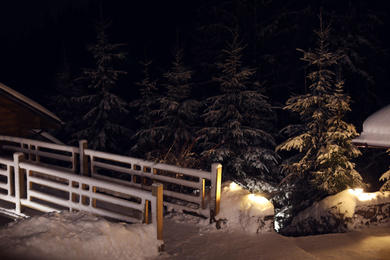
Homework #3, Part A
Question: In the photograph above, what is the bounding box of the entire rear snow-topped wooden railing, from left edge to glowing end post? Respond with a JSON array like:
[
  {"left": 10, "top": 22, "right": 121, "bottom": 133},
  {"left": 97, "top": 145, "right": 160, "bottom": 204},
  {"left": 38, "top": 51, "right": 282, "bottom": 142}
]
[{"left": 0, "top": 136, "right": 222, "bottom": 219}]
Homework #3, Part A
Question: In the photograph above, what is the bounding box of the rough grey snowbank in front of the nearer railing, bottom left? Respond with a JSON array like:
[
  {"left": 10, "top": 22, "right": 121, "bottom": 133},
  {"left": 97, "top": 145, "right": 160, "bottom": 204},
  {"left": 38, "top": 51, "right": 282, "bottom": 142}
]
[{"left": 0, "top": 211, "right": 161, "bottom": 260}]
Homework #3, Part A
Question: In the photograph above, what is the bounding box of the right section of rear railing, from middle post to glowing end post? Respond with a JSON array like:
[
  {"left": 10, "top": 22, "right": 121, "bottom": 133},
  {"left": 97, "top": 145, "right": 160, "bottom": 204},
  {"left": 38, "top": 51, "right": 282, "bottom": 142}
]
[{"left": 84, "top": 146, "right": 222, "bottom": 218}]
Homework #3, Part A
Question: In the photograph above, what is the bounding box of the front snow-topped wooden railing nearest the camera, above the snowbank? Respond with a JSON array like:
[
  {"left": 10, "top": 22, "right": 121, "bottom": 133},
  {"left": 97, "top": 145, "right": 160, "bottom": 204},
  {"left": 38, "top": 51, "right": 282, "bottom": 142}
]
[{"left": 0, "top": 152, "right": 163, "bottom": 240}]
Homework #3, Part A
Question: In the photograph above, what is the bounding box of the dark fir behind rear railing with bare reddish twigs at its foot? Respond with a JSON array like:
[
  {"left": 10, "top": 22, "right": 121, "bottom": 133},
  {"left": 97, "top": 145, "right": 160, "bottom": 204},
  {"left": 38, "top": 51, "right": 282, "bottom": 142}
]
[{"left": 152, "top": 45, "right": 201, "bottom": 167}]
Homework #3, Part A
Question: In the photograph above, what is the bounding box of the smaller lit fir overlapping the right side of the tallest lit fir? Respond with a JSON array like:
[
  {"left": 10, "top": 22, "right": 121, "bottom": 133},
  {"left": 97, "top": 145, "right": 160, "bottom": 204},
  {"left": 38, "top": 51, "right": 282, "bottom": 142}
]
[{"left": 314, "top": 81, "right": 365, "bottom": 194}]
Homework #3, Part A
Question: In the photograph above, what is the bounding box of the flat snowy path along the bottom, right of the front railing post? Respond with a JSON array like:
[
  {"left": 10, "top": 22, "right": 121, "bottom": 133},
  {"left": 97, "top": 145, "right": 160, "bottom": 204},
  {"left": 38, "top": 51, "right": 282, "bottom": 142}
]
[{"left": 155, "top": 218, "right": 390, "bottom": 260}]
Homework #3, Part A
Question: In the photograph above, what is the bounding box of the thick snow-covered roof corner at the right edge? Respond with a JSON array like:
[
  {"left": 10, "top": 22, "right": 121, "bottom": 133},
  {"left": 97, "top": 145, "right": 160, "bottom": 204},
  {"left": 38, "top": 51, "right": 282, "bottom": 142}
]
[{"left": 352, "top": 105, "right": 390, "bottom": 148}]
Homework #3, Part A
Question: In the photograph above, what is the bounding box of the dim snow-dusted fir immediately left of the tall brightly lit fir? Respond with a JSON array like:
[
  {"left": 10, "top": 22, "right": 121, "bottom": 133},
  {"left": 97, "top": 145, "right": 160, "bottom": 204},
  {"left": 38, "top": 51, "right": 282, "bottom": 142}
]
[{"left": 201, "top": 32, "right": 276, "bottom": 183}]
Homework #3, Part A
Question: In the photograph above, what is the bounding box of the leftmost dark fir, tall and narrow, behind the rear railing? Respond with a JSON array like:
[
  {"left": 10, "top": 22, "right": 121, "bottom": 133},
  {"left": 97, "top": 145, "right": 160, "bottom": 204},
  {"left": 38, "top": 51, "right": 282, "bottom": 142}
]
[{"left": 76, "top": 19, "right": 130, "bottom": 152}]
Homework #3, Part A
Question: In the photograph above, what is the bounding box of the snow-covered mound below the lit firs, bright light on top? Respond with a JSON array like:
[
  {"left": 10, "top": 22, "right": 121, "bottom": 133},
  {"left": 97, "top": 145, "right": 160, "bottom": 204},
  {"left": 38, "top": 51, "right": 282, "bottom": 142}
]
[{"left": 284, "top": 189, "right": 390, "bottom": 235}]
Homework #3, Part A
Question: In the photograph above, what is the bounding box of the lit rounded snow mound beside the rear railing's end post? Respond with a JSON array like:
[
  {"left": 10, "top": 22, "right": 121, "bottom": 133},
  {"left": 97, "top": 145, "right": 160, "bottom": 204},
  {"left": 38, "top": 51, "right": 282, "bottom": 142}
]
[{"left": 216, "top": 182, "right": 274, "bottom": 233}]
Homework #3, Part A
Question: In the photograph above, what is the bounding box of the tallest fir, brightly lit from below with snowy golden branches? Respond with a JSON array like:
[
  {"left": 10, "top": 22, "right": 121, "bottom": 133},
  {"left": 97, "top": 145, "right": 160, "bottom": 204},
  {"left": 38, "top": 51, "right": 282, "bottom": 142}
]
[{"left": 277, "top": 15, "right": 363, "bottom": 197}]
